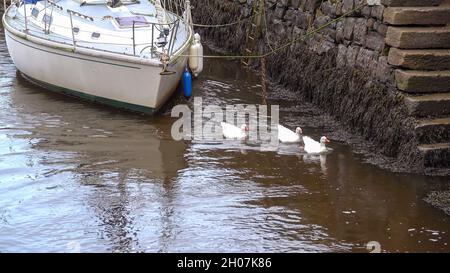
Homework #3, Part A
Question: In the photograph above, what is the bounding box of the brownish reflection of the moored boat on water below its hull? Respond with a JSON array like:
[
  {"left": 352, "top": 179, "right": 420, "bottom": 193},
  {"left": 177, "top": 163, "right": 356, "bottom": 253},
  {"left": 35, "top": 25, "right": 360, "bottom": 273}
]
[{"left": 10, "top": 72, "right": 187, "bottom": 180}]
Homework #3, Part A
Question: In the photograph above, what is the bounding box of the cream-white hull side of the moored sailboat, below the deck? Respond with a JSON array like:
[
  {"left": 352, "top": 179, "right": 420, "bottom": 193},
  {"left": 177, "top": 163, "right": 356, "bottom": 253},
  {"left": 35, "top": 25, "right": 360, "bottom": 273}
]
[{"left": 5, "top": 26, "right": 187, "bottom": 114}]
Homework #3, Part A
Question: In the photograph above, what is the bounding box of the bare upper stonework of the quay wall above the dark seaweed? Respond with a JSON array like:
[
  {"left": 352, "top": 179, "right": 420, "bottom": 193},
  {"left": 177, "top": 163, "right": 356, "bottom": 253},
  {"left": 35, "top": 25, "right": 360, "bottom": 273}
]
[{"left": 194, "top": 0, "right": 394, "bottom": 84}]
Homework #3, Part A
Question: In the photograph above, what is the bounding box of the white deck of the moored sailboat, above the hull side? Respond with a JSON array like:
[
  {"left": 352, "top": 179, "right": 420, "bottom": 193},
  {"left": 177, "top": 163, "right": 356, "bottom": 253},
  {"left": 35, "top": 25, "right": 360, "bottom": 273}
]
[{"left": 5, "top": 0, "right": 190, "bottom": 59}]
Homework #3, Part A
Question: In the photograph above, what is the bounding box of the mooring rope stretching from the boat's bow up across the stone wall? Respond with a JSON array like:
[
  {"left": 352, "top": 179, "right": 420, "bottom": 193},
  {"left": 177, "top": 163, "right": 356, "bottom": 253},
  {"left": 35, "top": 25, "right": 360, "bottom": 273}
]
[{"left": 178, "top": 4, "right": 367, "bottom": 59}]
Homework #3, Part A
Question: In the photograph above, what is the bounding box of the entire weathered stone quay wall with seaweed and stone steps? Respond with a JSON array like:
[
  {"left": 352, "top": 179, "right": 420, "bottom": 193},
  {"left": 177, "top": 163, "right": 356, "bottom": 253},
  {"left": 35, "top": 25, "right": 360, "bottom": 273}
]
[{"left": 192, "top": 0, "right": 450, "bottom": 172}]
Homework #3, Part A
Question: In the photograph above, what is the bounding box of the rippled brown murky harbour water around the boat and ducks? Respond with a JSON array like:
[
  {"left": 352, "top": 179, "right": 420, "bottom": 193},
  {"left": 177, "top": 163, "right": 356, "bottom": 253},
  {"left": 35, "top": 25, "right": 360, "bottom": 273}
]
[{"left": 0, "top": 24, "right": 450, "bottom": 252}]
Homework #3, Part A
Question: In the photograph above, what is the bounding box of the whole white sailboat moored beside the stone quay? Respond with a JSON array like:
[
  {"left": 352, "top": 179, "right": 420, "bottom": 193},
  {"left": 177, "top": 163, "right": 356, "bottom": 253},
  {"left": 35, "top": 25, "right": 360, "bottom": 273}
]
[{"left": 3, "top": 0, "right": 199, "bottom": 114}]
